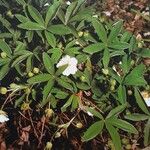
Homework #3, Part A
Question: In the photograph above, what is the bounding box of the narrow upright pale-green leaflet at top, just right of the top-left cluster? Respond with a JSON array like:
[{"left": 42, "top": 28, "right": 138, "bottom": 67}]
[{"left": 65, "top": 1, "right": 78, "bottom": 25}]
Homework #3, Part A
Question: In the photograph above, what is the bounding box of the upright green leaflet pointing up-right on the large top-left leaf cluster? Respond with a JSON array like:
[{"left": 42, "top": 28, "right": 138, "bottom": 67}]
[{"left": 45, "top": 1, "right": 60, "bottom": 27}]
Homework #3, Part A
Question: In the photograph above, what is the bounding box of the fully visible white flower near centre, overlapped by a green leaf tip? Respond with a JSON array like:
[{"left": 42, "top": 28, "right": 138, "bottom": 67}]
[{"left": 56, "top": 55, "right": 78, "bottom": 76}]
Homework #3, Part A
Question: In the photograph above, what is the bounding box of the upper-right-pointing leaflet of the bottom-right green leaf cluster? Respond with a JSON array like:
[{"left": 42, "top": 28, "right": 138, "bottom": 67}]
[{"left": 106, "top": 104, "right": 127, "bottom": 118}]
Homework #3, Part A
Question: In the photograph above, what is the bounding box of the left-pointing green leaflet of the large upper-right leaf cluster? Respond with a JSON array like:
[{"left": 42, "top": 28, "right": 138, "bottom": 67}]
[{"left": 83, "top": 43, "right": 105, "bottom": 55}]
